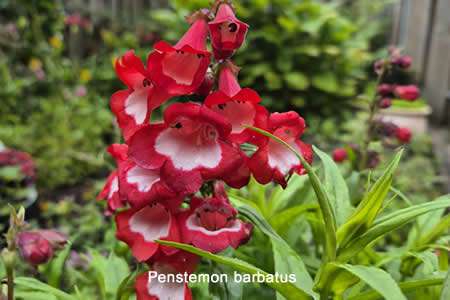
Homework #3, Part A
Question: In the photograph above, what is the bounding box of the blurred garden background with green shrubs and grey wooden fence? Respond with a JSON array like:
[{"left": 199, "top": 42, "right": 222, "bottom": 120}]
[{"left": 0, "top": 0, "right": 450, "bottom": 299}]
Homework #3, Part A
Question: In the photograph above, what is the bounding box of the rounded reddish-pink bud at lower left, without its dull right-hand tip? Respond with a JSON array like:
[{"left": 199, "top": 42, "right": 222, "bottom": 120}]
[{"left": 16, "top": 231, "right": 53, "bottom": 266}]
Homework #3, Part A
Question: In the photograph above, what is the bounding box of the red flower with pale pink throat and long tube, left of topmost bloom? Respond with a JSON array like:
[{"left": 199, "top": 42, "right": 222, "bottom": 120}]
[{"left": 147, "top": 12, "right": 211, "bottom": 95}]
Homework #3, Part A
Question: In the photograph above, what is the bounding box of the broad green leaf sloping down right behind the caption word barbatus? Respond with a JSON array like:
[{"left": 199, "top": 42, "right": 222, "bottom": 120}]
[{"left": 237, "top": 205, "right": 317, "bottom": 298}]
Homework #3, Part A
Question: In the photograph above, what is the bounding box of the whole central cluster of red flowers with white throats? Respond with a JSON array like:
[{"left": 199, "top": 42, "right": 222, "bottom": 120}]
[{"left": 99, "top": 0, "right": 312, "bottom": 299}]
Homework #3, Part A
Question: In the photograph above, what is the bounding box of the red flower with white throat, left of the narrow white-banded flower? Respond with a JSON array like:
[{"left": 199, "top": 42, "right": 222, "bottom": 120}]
[{"left": 116, "top": 203, "right": 180, "bottom": 261}]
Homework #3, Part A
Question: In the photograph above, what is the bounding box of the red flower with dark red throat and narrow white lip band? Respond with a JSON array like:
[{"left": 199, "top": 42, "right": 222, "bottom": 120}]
[{"left": 178, "top": 185, "right": 253, "bottom": 253}]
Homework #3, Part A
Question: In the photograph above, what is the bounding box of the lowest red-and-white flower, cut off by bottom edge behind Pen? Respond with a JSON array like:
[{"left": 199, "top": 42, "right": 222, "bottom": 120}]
[{"left": 135, "top": 264, "right": 192, "bottom": 300}]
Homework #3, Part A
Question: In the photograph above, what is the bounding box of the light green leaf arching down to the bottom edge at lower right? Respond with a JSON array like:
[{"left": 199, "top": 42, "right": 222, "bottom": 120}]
[{"left": 335, "top": 264, "right": 406, "bottom": 300}]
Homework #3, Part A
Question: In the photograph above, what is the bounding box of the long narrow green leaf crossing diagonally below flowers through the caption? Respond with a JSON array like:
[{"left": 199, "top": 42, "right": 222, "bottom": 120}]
[{"left": 157, "top": 240, "right": 309, "bottom": 300}]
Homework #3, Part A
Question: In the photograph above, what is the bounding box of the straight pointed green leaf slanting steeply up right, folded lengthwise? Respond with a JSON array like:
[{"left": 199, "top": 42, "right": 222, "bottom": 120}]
[{"left": 337, "top": 150, "right": 403, "bottom": 248}]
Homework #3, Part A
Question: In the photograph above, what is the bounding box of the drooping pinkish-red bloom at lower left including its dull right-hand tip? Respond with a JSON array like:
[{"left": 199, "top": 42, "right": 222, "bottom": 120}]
[{"left": 16, "top": 230, "right": 67, "bottom": 266}]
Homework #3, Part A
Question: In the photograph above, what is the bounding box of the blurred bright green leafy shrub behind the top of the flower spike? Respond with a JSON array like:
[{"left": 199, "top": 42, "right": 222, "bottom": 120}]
[{"left": 146, "top": 0, "right": 380, "bottom": 116}]
